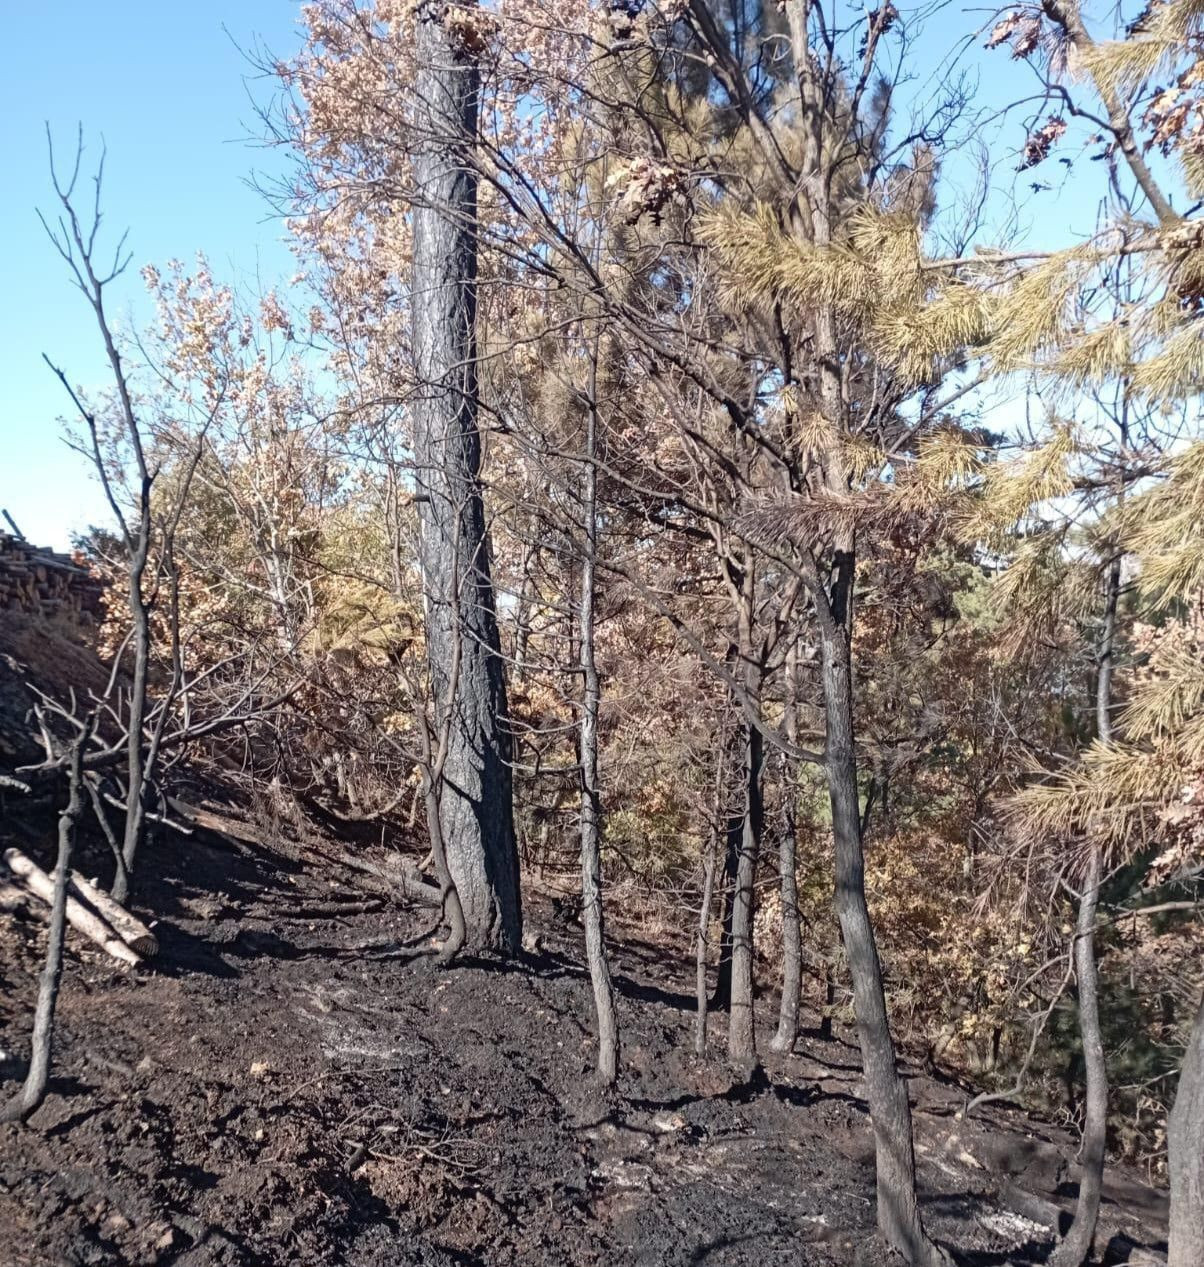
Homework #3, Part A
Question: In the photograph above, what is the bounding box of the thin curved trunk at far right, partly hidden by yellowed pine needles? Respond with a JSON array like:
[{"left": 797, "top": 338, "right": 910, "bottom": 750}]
[{"left": 1049, "top": 555, "right": 1125, "bottom": 1267}]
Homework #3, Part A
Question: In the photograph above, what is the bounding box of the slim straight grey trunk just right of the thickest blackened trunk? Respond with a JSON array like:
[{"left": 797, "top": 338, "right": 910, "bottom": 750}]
[{"left": 578, "top": 382, "right": 618, "bottom": 1083}]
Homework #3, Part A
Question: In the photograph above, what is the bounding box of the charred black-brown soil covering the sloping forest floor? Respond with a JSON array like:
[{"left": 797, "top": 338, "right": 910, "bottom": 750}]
[{"left": 0, "top": 802, "right": 1165, "bottom": 1267}]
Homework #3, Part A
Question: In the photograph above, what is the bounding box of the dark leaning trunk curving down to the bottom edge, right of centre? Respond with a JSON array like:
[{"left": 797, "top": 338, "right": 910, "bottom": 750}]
[{"left": 820, "top": 580, "right": 949, "bottom": 1267}]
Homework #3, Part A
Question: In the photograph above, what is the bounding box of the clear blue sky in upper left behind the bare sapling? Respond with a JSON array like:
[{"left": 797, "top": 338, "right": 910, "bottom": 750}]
[{"left": 0, "top": 0, "right": 299, "bottom": 545}]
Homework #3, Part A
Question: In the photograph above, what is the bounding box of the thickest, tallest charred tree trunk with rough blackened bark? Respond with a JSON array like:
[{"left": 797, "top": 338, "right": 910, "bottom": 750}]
[{"left": 411, "top": 4, "right": 522, "bottom": 954}]
